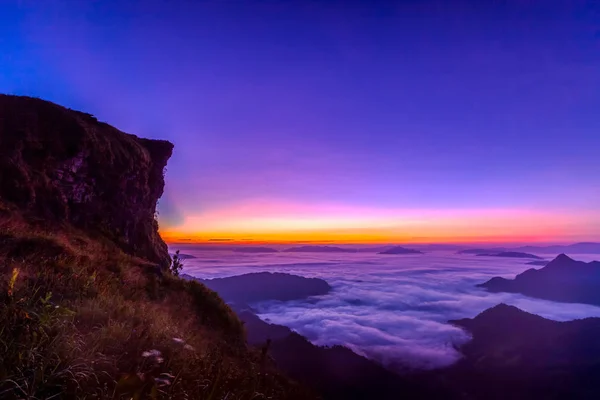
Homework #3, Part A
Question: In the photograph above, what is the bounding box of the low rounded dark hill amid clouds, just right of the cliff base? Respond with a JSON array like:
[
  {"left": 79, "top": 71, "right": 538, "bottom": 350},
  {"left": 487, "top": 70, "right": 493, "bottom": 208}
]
[{"left": 184, "top": 272, "right": 331, "bottom": 303}]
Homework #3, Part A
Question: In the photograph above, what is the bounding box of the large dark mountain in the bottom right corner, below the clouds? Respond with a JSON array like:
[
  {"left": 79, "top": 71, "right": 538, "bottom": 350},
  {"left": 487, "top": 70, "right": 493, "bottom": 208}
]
[{"left": 440, "top": 304, "right": 600, "bottom": 399}]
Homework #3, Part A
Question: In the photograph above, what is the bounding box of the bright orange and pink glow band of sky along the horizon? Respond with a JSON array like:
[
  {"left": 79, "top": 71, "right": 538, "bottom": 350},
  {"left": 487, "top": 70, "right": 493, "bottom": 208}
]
[{"left": 160, "top": 201, "right": 600, "bottom": 245}]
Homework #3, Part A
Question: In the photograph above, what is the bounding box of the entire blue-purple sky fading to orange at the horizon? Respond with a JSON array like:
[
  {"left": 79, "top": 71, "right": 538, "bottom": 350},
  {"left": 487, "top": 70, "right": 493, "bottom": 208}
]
[{"left": 0, "top": 0, "right": 600, "bottom": 242}]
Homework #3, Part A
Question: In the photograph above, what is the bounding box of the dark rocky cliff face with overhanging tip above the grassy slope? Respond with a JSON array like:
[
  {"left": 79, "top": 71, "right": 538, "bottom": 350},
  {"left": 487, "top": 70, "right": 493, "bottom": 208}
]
[{"left": 0, "top": 95, "right": 173, "bottom": 267}]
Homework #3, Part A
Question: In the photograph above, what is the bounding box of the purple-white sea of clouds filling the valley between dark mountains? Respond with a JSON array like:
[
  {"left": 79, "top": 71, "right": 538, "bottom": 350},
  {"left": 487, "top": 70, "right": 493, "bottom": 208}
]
[{"left": 182, "top": 248, "right": 600, "bottom": 369}]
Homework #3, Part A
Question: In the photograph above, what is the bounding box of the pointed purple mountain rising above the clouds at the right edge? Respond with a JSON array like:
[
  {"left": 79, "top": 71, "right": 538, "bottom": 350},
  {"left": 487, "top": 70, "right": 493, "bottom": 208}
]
[{"left": 477, "top": 254, "right": 600, "bottom": 305}]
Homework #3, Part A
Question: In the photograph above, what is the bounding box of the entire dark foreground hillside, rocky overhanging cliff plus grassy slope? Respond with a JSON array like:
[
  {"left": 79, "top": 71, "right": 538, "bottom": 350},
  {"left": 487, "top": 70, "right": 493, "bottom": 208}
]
[{"left": 0, "top": 96, "right": 311, "bottom": 399}]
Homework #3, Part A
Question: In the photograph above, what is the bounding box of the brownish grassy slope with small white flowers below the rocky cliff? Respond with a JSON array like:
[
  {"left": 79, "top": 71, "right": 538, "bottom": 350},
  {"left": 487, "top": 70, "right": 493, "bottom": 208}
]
[{"left": 0, "top": 216, "right": 312, "bottom": 400}]
